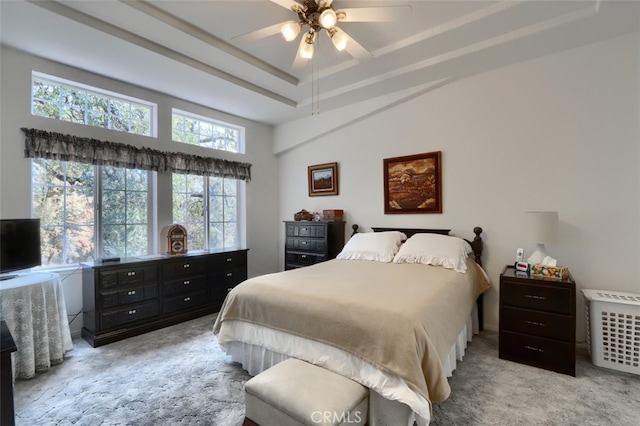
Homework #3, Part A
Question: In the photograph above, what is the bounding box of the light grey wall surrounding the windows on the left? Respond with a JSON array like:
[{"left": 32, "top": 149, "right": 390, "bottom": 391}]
[{"left": 0, "top": 46, "right": 279, "bottom": 334}]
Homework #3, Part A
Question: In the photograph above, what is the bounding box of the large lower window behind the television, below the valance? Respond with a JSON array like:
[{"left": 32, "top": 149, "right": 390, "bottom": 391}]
[{"left": 32, "top": 159, "right": 151, "bottom": 266}]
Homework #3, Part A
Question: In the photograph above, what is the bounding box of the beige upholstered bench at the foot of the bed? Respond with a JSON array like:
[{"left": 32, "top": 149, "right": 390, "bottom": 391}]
[{"left": 244, "top": 358, "right": 369, "bottom": 426}]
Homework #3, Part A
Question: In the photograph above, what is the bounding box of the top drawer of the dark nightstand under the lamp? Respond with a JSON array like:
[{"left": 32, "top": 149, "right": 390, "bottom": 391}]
[{"left": 500, "top": 281, "right": 573, "bottom": 315}]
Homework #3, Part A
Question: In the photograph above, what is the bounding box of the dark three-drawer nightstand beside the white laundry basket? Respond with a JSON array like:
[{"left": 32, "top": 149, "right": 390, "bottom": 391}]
[{"left": 499, "top": 265, "right": 576, "bottom": 376}]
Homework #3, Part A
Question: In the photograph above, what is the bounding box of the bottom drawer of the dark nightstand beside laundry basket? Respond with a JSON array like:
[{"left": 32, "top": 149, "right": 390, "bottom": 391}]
[{"left": 500, "top": 331, "right": 575, "bottom": 376}]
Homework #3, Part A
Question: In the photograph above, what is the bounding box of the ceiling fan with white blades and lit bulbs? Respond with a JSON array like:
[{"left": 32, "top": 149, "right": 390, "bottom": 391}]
[{"left": 234, "top": 0, "right": 411, "bottom": 68}]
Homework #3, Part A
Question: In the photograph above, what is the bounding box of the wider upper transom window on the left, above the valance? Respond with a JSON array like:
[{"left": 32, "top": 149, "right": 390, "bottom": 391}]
[{"left": 31, "top": 72, "right": 156, "bottom": 136}]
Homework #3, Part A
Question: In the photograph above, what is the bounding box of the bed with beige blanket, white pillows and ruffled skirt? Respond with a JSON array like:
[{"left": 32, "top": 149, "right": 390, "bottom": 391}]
[{"left": 213, "top": 226, "right": 489, "bottom": 426}]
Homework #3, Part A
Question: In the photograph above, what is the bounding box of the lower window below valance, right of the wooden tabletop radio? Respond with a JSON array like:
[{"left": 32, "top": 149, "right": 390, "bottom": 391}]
[{"left": 173, "top": 174, "right": 243, "bottom": 250}]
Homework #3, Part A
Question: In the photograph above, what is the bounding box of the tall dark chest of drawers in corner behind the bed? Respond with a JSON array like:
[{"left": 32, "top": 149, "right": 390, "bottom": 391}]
[{"left": 284, "top": 221, "right": 345, "bottom": 270}]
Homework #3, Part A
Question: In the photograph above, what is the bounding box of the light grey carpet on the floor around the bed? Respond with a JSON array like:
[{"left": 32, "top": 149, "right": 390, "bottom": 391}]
[{"left": 15, "top": 316, "right": 640, "bottom": 426}]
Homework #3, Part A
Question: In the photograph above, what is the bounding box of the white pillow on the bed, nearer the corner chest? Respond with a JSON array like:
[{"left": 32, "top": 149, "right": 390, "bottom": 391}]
[{"left": 336, "top": 231, "right": 407, "bottom": 262}]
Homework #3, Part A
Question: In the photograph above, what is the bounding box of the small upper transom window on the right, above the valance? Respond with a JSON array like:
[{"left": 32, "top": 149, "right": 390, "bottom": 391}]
[{"left": 171, "top": 109, "right": 244, "bottom": 153}]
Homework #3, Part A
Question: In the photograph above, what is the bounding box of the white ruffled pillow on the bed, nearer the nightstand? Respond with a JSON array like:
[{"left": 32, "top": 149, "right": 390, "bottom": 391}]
[{"left": 393, "top": 234, "right": 473, "bottom": 272}]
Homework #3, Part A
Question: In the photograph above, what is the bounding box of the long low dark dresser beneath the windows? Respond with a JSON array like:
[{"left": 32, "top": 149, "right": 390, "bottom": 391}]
[{"left": 82, "top": 249, "right": 247, "bottom": 347}]
